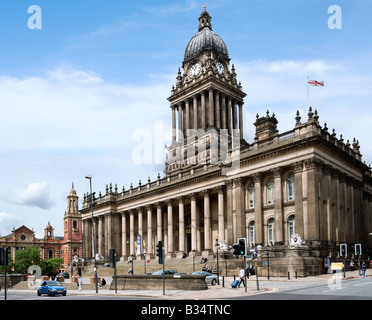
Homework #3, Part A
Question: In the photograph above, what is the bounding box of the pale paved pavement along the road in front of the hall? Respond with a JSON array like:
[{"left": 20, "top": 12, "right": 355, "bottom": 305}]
[{"left": 11, "top": 271, "right": 371, "bottom": 300}]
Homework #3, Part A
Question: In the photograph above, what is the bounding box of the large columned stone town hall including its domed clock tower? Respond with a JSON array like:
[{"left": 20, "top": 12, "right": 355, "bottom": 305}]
[{"left": 81, "top": 8, "right": 372, "bottom": 276}]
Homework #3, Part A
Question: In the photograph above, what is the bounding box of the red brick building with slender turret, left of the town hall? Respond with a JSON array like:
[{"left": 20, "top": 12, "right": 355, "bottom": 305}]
[{"left": 0, "top": 184, "right": 83, "bottom": 271}]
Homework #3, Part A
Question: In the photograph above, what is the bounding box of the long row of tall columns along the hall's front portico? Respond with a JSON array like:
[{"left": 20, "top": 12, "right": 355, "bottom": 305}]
[{"left": 84, "top": 185, "right": 232, "bottom": 257}]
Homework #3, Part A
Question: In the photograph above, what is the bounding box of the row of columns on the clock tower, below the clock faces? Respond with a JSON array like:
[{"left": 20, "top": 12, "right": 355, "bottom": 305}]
[{"left": 171, "top": 89, "right": 244, "bottom": 142}]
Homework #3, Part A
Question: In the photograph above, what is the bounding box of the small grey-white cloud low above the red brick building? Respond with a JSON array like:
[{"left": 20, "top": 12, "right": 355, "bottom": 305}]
[{"left": 3, "top": 181, "right": 55, "bottom": 210}]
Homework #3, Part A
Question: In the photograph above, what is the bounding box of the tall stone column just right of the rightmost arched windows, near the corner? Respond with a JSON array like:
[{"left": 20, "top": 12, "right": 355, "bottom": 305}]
[{"left": 292, "top": 161, "right": 305, "bottom": 239}]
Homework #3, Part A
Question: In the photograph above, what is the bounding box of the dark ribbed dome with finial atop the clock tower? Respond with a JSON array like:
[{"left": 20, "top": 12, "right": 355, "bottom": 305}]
[{"left": 184, "top": 5, "right": 229, "bottom": 61}]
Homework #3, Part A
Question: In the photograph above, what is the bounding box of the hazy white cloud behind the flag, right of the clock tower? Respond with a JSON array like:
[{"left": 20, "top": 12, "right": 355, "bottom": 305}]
[{"left": 235, "top": 57, "right": 372, "bottom": 163}]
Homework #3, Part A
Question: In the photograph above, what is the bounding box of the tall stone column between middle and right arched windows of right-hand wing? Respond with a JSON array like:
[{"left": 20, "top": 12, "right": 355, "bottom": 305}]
[{"left": 271, "top": 168, "right": 284, "bottom": 244}]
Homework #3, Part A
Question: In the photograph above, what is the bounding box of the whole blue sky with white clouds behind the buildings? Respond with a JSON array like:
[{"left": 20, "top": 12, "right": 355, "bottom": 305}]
[{"left": 0, "top": 0, "right": 372, "bottom": 236}]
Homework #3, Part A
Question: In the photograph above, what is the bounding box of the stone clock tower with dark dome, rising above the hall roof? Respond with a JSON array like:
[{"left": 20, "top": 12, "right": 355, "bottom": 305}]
[{"left": 165, "top": 5, "right": 247, "bottom": 176}]
